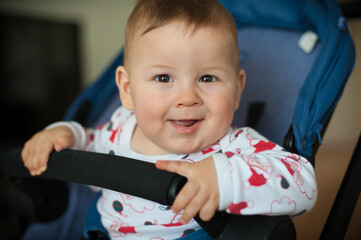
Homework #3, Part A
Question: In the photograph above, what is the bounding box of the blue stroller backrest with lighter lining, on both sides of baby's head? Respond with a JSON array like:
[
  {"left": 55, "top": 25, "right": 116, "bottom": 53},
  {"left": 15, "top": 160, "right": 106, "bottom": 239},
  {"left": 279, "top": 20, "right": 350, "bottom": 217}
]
[{"left": 66, "top": 0, "right": 355, "bottom": 160}]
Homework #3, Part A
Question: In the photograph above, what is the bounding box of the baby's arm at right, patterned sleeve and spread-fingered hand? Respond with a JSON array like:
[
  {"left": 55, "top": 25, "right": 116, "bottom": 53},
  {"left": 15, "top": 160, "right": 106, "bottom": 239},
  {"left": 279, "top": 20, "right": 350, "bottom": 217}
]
[{"left": 156, "top": 129, "right": 317, "bottom": 223}]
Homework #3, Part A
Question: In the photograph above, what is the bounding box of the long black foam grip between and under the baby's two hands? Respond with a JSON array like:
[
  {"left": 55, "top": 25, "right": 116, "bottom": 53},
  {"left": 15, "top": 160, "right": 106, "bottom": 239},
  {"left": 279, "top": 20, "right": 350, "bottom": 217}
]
[{"left": 0, "top": 148, "right": 186, "bottom": 205}]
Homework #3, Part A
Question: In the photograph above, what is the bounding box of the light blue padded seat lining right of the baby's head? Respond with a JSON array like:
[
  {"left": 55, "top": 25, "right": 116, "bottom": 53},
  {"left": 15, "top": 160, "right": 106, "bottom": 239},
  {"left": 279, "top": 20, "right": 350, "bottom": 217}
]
[{"left": 234, "top": 27, "right": 320, "bottom": 145}]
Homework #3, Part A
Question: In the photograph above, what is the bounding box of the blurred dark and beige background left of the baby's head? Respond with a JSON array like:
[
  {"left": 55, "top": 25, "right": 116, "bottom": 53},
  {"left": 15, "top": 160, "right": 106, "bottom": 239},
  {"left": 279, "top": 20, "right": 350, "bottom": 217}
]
[{"left": 0, "top": 0, "right": 135, "bottom": 150}]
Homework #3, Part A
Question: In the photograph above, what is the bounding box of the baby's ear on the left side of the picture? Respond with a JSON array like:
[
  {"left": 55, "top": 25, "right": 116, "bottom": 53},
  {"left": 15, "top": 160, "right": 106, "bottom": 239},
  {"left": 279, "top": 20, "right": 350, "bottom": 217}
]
[{"left": 115, "top": 66, "right": 134, "bottom": 110}]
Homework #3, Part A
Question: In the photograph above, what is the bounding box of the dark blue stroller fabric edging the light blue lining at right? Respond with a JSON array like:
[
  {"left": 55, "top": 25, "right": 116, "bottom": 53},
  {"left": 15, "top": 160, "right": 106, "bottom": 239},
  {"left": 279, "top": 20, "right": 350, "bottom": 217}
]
[{"left": 223, "top": 0, "right": 355, "bottom": 157}]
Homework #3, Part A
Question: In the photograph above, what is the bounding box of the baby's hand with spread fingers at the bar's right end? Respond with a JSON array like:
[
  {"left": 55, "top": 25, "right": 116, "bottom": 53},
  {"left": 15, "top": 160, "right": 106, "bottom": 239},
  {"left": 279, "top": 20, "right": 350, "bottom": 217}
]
[{"left": 156, "top": 157, "right": 219, "bottom": 224}]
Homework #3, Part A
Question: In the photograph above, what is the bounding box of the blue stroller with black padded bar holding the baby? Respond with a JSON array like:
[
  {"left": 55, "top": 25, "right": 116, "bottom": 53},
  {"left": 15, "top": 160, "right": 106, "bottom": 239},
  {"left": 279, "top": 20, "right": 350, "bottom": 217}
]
[{"left": 1, "top": 0, "right": 354, "bottom": 239}]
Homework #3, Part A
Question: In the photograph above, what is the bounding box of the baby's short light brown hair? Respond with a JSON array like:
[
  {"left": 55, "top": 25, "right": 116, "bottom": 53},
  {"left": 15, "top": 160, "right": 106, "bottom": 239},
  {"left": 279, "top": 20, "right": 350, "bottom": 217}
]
[{"left": 124, "top": 0, "right": 237, "bottom": 65}]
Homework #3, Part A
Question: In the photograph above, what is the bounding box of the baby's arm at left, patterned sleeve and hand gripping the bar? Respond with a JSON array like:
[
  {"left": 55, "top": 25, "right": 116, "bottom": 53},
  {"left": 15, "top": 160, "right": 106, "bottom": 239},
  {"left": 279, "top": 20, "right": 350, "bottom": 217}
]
[{"left": 21, "top": 107, "right": 131, "bottom": 175}]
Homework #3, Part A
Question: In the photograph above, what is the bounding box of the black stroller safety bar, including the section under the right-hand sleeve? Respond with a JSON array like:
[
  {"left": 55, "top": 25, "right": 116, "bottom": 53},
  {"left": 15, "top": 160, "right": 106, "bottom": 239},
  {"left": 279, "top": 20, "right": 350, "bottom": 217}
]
[{"left": 0, "top": 148, "right": 296, "bottom": 240}]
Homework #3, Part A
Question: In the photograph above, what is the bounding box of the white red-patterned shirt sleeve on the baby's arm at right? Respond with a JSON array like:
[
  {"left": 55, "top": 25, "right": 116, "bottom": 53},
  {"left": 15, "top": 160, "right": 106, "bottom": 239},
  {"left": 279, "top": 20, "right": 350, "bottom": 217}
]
[{"left": 213, "top": 128, "right": 317, "bottom": 216}]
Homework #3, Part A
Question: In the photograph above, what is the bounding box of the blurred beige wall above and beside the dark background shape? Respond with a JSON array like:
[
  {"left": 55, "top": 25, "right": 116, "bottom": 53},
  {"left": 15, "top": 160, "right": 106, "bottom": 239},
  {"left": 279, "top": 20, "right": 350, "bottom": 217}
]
[{"left": 0, "top": 0, "right": 135, "bottom": 86}]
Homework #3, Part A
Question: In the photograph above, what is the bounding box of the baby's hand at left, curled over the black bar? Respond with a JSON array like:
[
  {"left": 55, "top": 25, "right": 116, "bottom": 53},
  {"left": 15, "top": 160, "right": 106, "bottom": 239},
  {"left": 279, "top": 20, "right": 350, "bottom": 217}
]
[{"left": 21, "top": 126, "right": 75, "bottom": 176}]
